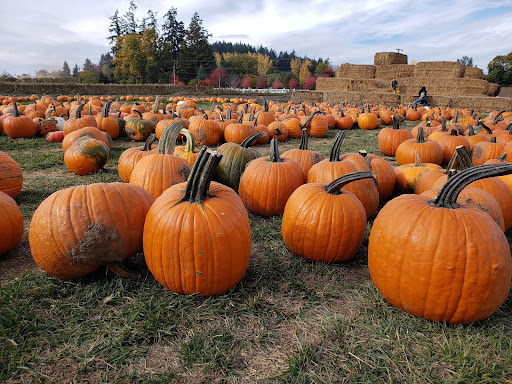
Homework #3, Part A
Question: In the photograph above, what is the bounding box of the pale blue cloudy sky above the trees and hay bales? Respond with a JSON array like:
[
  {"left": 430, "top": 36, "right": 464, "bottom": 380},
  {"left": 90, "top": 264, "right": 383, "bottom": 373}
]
[{"left": 0, "top": 0, "right": 512, "bottom": 76}]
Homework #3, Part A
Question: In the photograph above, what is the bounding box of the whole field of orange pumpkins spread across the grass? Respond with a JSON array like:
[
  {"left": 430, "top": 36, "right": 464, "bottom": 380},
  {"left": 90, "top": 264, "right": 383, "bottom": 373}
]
[{"left": 0, "top": 95, "right": 512, "bottom": 380}]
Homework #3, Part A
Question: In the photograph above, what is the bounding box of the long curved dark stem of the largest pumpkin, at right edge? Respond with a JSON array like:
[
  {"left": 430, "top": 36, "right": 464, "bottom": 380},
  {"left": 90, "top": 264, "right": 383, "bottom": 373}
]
[{"left": 431, "top": 163, "right": 512, "bottom": 209}]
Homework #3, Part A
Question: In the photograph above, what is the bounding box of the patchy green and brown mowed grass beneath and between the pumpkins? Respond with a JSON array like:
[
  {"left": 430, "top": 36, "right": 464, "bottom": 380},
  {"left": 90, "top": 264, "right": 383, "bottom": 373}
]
[{"left": 0, "top": 115, "right": 512, "bottom": 383}]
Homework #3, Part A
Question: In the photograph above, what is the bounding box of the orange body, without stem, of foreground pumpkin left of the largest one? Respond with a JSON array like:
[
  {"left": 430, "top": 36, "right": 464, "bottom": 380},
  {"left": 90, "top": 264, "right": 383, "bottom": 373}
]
[{"left": 281, "top": 183, "right": 366, "bottom": 263}]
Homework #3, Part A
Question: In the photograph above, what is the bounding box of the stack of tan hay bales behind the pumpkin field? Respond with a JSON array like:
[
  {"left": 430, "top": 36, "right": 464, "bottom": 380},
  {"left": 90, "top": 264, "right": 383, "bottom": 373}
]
[{"left": 302, "top": 52, "right": 512, "bottom": 111}]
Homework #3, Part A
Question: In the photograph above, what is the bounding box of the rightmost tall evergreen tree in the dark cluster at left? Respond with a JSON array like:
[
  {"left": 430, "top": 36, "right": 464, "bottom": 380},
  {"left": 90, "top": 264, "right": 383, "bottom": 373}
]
[{"left": 178, "top": 12, "right": 215, "bottom": 82}]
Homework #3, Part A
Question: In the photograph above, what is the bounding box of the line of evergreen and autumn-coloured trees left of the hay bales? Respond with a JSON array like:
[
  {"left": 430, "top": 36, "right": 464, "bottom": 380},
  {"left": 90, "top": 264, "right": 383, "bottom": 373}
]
[{"left": 63, "top": 1, "right": 334, "bottom": 87}]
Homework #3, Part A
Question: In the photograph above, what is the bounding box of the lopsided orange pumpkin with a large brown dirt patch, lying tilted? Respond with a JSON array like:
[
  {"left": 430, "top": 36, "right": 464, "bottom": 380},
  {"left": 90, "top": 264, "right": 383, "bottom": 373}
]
[{"left": 29, "top": 183, "right": 154, "bottom": 279}]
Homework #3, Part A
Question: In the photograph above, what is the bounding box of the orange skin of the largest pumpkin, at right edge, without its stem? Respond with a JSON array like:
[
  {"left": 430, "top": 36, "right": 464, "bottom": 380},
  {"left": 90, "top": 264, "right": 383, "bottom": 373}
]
[{"left": 368, "top": 195, "right": 512, "bottom": 324}]
